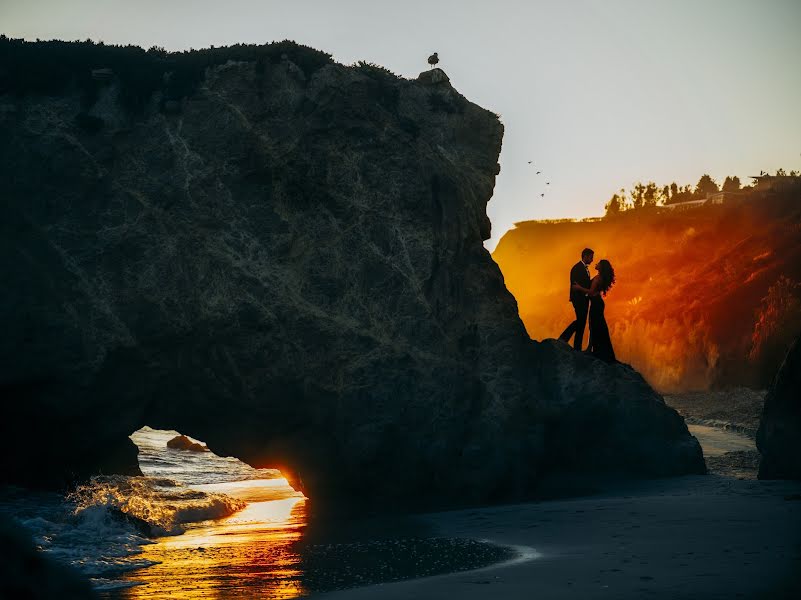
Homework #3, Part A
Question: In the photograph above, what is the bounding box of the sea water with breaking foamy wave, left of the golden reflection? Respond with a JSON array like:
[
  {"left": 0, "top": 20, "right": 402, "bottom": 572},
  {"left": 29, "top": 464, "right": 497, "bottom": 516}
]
[{"left": 0, "top": 427, "right": 296, "bottom": 592}]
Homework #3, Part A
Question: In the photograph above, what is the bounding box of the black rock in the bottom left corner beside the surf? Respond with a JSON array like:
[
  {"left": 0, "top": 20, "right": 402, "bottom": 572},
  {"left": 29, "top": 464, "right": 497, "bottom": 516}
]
[{"left": 0, "top": 517, "right": 97, "bottom": 600}]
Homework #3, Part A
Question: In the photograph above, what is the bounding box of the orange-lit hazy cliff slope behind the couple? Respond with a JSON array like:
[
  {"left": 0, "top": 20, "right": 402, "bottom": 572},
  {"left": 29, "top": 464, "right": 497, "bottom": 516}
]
[{"left": 493, "top": 189, "right": 801, "bottom": 391}]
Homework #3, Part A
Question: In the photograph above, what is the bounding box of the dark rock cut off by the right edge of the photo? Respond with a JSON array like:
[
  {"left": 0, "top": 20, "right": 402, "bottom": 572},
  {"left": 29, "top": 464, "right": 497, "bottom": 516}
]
[{"left": 757, "top": 337, "right": 801, "bottom": 479}]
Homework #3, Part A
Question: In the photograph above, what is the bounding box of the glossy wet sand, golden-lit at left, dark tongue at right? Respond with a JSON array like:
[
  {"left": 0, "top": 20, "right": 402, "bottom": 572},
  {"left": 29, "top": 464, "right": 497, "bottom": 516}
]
[{"left": 102, "top": 479, "right": 516, "bottom": 600}]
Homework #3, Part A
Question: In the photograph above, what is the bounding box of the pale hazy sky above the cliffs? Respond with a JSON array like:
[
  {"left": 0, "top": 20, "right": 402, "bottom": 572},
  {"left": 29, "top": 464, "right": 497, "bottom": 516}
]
[{"left": 0, "top": 0, "right": 801, "bottom": 249}]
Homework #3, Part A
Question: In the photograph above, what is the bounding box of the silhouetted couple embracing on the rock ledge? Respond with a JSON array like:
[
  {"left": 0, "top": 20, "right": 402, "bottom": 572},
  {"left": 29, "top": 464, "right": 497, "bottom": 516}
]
[{"left": 559, "top": 248, "right": 616, "bottom": 362}]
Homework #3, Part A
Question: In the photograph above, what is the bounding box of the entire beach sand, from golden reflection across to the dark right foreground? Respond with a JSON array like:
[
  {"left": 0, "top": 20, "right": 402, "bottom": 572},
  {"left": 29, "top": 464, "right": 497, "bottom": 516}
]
[{"left": 113, "top": 406, "right": 801, "bottom": 600}]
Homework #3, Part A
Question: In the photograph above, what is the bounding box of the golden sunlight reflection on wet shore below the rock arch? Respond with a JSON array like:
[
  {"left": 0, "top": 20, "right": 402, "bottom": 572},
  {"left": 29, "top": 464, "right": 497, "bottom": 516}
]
[{"left": 120, "top": 479, "right": 307, "bottom": 600}]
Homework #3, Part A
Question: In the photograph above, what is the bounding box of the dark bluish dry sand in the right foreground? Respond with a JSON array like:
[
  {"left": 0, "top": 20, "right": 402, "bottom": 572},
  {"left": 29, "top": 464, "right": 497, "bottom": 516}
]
[{"left": 315, "top": 475, "right": 801, "bottom": 600}]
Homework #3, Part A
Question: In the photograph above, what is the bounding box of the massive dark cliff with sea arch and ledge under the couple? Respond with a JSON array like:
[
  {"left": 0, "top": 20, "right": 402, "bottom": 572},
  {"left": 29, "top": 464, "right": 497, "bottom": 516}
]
[{"left": 0, "top": 43, "right": 703, "bottom": 507}]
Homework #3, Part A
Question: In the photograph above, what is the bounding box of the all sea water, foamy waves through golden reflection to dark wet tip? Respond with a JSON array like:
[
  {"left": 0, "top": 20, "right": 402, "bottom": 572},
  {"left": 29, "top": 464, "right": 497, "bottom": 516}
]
[{"left": 0, "top": 427, "right": 515, "bottom": 599}]
